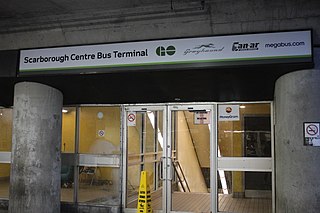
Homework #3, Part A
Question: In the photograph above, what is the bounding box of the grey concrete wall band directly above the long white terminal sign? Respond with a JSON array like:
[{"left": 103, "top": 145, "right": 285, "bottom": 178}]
[{"left": 0, "top": 0, "right": 320, "bottom": 50}]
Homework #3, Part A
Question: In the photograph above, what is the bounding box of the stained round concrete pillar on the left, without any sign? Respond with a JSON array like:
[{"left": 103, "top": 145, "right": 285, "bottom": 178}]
[{"left": 9, "top": 82, "right": 62, "bottom": 213}]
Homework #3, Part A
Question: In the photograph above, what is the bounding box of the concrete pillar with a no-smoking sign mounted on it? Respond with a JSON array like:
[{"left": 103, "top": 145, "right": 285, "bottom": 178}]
[{"left": 275, "top": 70, "right": 320, "bottom": 213}]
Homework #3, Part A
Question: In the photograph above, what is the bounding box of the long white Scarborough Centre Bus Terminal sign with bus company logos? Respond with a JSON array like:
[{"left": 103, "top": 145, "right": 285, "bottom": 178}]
[{"left": 19, "top": 31, "right": 312, "bottom": 74}]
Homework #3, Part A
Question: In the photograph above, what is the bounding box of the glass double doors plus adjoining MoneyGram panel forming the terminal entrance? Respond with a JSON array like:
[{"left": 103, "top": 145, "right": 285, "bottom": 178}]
[{"left": 122, "top": 102, "right": 274, "bottom": 213}]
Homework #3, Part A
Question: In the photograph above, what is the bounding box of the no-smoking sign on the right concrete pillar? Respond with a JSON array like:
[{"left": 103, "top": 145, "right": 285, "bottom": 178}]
[{"left": 303, "top": 122, "right": 320, "bottom": 146}]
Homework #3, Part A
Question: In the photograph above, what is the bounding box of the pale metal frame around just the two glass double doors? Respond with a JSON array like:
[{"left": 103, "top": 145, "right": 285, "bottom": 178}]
[{"left": 122, "top": 103, "right": 217, "bottom": 212}]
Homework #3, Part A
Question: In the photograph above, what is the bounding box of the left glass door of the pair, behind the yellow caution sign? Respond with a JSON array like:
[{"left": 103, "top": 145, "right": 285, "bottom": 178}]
[{"left": 123, "top": 106, "right": 166, "bottom": 212}]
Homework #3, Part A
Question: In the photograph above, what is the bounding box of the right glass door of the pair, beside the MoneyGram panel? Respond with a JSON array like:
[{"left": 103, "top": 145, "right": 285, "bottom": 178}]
[{"left": 167, "top": 105, "right": 216, "bottom": 212}]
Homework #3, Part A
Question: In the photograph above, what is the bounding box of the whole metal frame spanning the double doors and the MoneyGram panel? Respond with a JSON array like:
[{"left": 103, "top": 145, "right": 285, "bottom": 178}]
[{"left": 121, "top": 101, "right": 275, "bottom": 212}]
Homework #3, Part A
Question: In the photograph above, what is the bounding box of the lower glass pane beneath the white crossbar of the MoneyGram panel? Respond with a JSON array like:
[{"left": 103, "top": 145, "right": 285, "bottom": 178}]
[{"left": 217, "top": 171, "right": 272, "bottom": 213}]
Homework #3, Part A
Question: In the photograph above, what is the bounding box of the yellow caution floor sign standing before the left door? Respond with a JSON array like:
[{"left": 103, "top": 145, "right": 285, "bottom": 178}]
[{"left": 137, "top": 171, "right": 152, "bottom": 213}]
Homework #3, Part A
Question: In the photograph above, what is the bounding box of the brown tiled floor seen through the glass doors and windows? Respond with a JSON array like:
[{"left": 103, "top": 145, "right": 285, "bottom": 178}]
[{"left": 0, "top": 181, "right": 272, "bottom": 213}]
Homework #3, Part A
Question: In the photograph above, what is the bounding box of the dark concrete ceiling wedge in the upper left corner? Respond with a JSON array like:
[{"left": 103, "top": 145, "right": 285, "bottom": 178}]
[{"left": 0, "top": 0, "right": 190, "bottom": 27}]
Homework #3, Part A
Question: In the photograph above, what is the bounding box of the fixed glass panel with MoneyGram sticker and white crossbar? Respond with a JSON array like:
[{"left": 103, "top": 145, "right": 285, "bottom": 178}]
[{"left": 217, "top": 103, "right": 274, "bottom": 213}]
